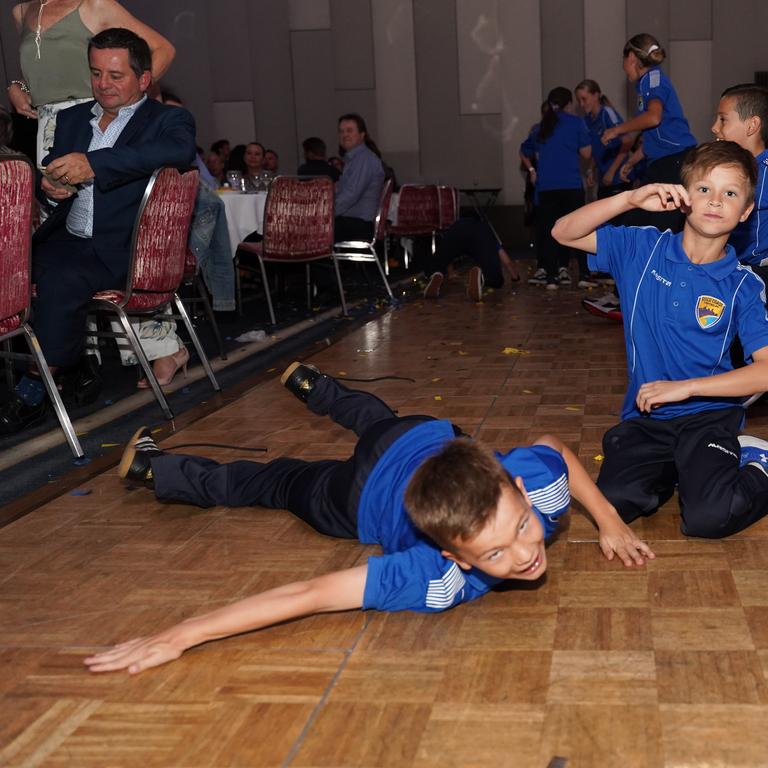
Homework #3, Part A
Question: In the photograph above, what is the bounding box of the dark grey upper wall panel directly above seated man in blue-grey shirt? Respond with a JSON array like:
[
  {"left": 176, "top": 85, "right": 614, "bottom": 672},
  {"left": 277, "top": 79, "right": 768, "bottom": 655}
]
[{"left": 331, "top": 0, "right": 376, "bottom": 90}]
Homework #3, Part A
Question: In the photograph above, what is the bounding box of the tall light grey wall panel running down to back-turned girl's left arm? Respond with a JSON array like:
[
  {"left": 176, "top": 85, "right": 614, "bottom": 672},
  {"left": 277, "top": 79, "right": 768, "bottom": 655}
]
[{"left": 498, "top": 0, "right": 542, "bottom": 205}]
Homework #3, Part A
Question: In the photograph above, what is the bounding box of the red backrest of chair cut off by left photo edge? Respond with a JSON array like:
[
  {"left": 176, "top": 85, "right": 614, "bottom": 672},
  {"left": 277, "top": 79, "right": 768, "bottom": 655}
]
[{"left": 0, "top": 154, "right": 35, "bottom": 320}]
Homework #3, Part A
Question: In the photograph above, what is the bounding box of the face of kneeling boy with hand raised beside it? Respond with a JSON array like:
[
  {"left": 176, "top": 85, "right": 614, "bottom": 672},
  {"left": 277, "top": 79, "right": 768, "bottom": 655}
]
[{"left": 686, "top": 165, "right": 754, "bottom": 237}]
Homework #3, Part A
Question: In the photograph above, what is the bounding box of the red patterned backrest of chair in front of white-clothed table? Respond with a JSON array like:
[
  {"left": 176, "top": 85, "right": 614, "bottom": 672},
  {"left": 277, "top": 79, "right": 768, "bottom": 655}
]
[{"left": 262, "top": 176, "right": 334, "bottom": 261}]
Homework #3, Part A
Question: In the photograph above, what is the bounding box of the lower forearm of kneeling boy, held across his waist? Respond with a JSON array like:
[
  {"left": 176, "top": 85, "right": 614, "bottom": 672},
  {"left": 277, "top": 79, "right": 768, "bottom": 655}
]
[{"left": 635, "top": 347, "right": 768, "bottom": 413}]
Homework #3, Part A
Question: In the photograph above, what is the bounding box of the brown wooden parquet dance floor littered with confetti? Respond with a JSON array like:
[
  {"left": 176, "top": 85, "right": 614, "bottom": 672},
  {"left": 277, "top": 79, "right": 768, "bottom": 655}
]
[{"left": 0, "top": 266, "right": 768, "bottom": 768}]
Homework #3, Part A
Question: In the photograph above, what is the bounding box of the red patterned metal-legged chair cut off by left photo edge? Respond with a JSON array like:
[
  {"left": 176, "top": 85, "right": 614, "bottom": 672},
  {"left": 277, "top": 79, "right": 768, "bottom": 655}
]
[{"left": 0, "top": 155, "right": 84, "bottom": 458}]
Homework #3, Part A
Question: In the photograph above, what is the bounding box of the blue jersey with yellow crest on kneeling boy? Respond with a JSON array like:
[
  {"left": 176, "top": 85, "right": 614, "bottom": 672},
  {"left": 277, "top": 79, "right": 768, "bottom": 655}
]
[{"left": 589, "top": 225, "right": 768, "bottom": 419}]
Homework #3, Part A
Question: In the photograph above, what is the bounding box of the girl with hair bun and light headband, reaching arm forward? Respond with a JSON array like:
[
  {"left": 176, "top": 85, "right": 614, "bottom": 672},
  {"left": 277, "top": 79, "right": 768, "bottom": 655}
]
[{"left": 602, "top": 33, "right": 696, "bottom": 231}]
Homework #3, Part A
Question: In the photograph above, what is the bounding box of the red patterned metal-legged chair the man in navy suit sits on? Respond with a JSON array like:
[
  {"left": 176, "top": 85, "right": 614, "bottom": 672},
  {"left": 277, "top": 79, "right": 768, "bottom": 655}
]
[{"left": 91, "top": 168, "right": 221, "bottom": 419}]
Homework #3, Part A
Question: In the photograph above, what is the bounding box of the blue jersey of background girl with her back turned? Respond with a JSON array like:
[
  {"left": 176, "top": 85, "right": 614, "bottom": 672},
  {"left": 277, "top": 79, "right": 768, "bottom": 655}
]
[{"left": 532, "top": 112, "right": 591, "bottom": 192}]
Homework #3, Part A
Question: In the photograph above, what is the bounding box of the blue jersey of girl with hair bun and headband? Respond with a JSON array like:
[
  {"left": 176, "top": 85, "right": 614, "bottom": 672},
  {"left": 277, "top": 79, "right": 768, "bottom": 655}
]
[{"left": 635, "top": 67, "right": 696, "bottom": 162}]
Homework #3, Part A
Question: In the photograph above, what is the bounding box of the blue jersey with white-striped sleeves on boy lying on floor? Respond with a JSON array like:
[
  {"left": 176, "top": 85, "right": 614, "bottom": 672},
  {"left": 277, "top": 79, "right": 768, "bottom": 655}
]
[{"left": 358, "top": 421, "right": 570, "bottom": 613}]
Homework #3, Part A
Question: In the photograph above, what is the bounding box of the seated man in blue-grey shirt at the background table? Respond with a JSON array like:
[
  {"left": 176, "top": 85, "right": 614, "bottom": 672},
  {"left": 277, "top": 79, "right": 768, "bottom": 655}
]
[{"left": 336, "top": 114, "right": 384, "bottom": 242}]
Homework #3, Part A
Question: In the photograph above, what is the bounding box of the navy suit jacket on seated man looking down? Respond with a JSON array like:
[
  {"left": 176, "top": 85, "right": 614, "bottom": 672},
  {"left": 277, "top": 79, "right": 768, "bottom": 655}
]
[{"left": 34, "top": 99, "right": 196, "bottom": 275}]
